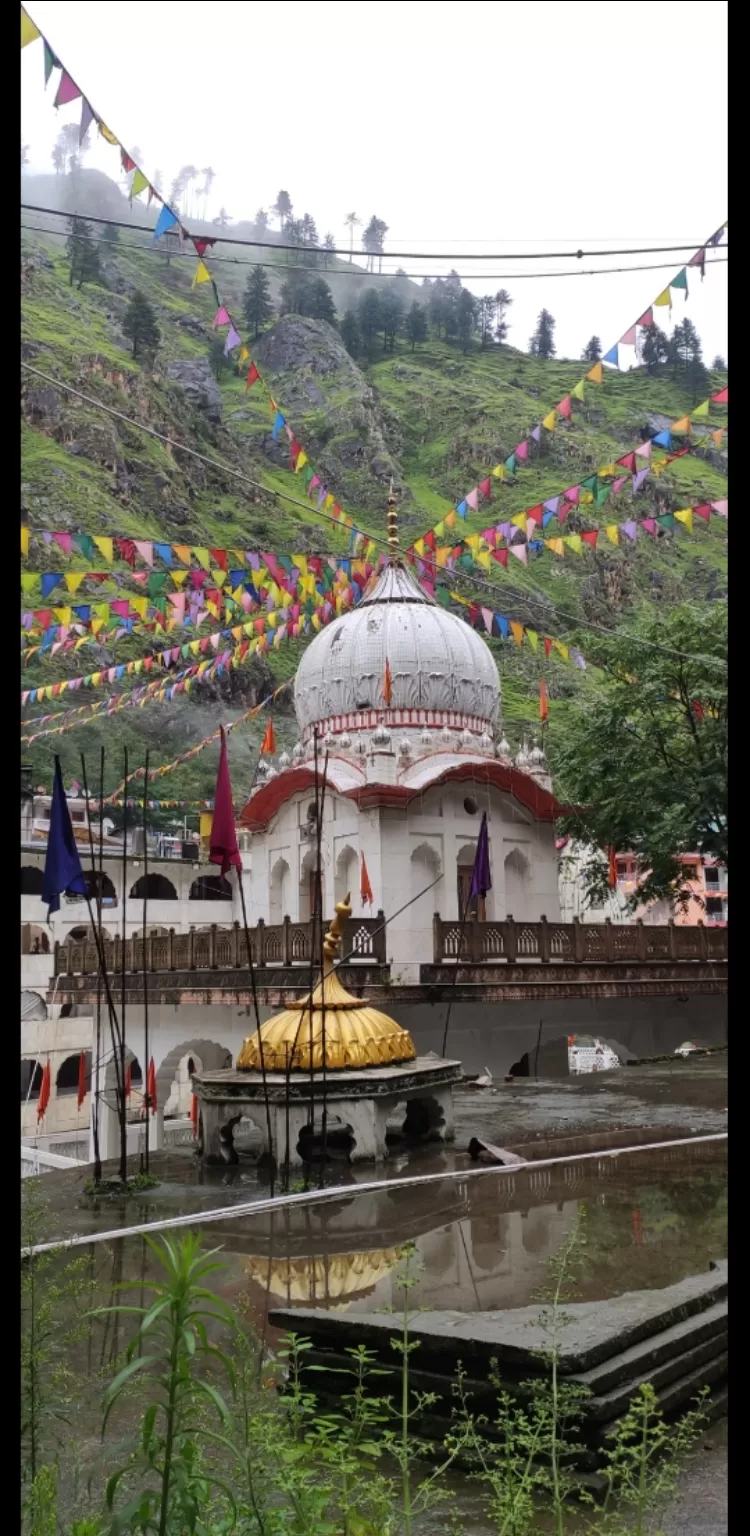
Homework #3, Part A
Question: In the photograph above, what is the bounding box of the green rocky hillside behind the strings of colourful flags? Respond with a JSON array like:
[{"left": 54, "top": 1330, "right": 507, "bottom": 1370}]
[{"left": 22, "top": 178, "right": 727, "bottom": 817}]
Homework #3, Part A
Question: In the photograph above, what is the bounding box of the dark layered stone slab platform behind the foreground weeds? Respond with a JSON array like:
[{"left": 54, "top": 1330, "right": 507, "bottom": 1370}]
[{"left": 269, "top": 1260, "right": 728, "bottom": 1444}]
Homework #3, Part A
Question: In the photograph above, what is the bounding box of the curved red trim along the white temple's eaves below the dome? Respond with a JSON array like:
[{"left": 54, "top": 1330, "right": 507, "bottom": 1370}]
[{"left": 238, "top": 762, "right": 563, "bottom": 833}]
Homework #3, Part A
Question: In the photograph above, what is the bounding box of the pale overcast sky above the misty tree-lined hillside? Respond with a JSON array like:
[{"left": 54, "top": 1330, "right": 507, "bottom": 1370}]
[{"left": 22, "top": 0, "right": 728, "bottom": 362}]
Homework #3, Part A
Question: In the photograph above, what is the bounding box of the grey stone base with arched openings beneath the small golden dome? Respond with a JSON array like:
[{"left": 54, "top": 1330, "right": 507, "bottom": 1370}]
[{"left": 192, "top": 1057, "right": 461, "bottom": 1167}]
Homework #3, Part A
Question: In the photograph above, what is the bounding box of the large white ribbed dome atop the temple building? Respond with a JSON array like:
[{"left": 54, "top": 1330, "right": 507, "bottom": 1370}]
[{"left": 295, "top": 561, "right": 499, "bottom": 731}]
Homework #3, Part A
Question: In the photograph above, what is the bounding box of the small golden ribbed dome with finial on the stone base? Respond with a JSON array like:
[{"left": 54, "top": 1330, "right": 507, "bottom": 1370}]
[{"left": 237, "top": 897, "right": 416, "bottom": 1072}]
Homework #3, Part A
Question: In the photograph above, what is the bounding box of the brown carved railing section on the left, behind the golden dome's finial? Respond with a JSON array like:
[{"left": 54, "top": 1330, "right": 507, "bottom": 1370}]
[{"left": 54, "top": 912, "right": 386, "bottom": 975}]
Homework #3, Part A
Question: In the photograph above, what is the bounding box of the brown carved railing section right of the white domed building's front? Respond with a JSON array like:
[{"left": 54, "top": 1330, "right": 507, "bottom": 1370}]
[{"left": 433, "top": 912, "right": 728, "bottom": 965}]
